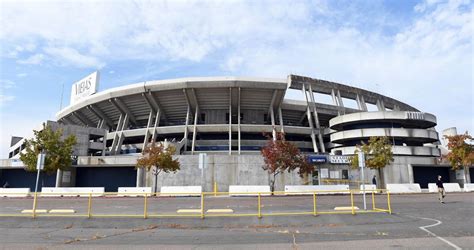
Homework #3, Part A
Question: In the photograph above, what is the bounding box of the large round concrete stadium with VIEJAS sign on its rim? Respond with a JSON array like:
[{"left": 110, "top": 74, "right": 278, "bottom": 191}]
[{"left": 0, "top": 72, "right": 466, "bottom": 191}]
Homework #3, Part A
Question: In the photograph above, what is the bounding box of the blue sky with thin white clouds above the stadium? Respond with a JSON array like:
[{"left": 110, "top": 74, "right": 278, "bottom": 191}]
[{"left": 0, "top": 0, "right": 474, "bottom": 158}]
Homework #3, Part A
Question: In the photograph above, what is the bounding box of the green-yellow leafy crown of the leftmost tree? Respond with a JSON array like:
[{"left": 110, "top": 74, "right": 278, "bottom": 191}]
[{"left": 20, "top": 123, "right": 76, "bottom": 174}]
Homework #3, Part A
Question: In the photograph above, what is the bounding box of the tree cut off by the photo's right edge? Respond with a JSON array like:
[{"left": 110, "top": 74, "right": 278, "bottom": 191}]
[{"left": 444, "top": 131, "right": 474, "bottom": 183}]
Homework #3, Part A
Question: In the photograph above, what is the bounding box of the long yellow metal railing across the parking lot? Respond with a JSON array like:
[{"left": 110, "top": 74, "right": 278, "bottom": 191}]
[{"left": 0, "top": 189, "right": 392, "bottom": 219}]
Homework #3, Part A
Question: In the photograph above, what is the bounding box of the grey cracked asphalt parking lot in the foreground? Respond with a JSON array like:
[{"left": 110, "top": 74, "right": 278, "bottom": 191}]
[{"left": 0, "top": 193, "right": 474, "bottom": 249}]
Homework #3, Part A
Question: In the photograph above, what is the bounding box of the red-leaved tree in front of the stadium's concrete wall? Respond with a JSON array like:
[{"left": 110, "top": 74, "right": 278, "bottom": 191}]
[{"left": 261, "top": 133, "right": 314, "bottom": 193}]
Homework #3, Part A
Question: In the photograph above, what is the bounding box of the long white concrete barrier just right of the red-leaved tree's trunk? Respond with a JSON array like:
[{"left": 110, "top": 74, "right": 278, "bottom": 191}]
[{"left": 285, "top": 184, "right": 350, "bottom": 195}]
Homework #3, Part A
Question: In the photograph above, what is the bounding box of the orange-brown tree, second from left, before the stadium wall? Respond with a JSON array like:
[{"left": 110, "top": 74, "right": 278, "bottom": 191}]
[{"left": 136, "top": 142, "right": 180, "bottom": 192}]
